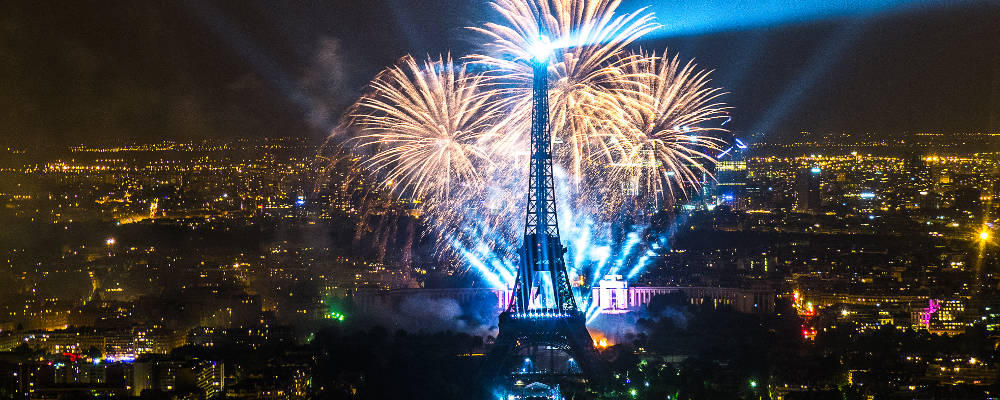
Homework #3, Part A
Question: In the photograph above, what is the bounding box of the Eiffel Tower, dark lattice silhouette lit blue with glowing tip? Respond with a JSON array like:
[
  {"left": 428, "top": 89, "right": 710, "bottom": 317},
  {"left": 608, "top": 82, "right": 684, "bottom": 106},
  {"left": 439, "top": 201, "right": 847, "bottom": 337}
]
[{"left": 481, "top": 36, "right": 605, "bottom": 398}]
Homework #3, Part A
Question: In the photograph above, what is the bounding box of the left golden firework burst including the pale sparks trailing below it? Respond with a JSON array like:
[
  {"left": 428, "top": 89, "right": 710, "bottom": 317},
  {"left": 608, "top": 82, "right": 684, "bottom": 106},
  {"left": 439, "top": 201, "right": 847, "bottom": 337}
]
[{"left": 349, "top": 56, "right": 520, "bottom": 266}]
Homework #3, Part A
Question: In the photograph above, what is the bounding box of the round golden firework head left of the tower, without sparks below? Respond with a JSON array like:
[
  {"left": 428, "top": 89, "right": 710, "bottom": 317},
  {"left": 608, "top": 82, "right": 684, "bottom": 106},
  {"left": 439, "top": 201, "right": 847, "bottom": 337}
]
[{"left": 352, "top": 56, "right": 508, "bottom": 199}]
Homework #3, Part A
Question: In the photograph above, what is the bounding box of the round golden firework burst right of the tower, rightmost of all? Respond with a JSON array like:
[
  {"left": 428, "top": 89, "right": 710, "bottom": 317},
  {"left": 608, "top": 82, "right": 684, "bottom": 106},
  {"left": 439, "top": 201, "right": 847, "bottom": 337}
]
[{"left": 591, "top": 52, "right": 729, "bottom": 202}]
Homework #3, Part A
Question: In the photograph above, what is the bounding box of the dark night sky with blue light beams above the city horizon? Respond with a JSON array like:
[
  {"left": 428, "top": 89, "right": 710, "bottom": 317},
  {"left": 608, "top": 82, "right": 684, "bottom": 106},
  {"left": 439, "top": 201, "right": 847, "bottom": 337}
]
[{"left": 0, "top": 0, "right": 1000, "bottom": 144}]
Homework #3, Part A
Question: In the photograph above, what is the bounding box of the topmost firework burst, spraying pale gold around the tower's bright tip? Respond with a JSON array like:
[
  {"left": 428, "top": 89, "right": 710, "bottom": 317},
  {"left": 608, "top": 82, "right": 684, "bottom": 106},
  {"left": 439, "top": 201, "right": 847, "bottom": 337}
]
[{"left": 469, "top": 0, "right": 659, "bottom": 183}]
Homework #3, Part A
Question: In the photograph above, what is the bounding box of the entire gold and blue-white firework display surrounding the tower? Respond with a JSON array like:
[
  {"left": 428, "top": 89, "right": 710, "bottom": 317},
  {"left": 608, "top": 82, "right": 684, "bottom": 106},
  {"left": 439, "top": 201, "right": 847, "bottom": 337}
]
[{"left": 332, "top": 0, "right": 728, "bottom": 294}]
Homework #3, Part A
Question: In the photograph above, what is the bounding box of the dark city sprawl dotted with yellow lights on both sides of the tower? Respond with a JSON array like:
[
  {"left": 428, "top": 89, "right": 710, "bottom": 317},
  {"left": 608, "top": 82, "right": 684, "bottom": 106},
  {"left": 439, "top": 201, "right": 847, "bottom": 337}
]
[{"left": 0, "top": 130, "right": 1000, "bottom": 397}]
